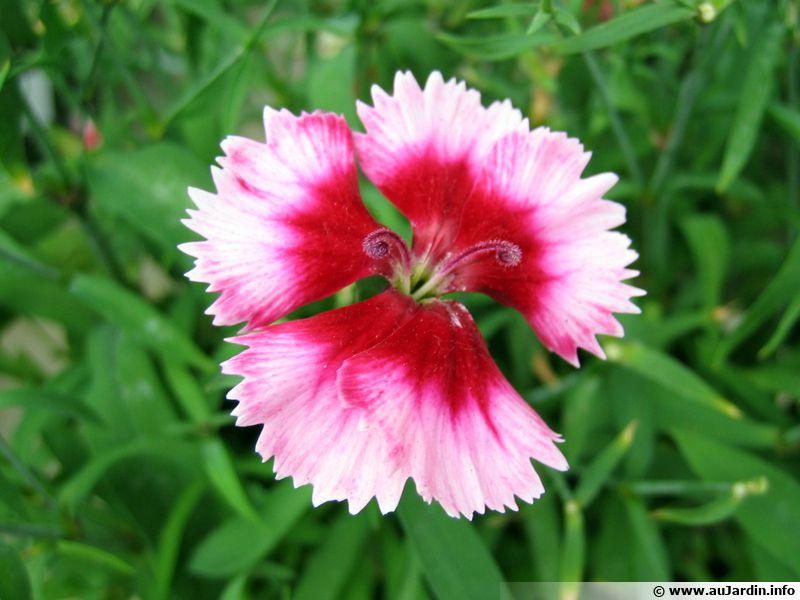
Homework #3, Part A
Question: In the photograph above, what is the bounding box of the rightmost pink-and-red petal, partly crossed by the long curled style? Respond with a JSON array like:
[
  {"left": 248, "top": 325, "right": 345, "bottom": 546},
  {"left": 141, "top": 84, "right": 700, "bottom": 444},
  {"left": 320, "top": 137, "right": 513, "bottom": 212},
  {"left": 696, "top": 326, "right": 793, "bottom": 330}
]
[{"left": 449, "top": 128, "right": 643, "bottom": 366}]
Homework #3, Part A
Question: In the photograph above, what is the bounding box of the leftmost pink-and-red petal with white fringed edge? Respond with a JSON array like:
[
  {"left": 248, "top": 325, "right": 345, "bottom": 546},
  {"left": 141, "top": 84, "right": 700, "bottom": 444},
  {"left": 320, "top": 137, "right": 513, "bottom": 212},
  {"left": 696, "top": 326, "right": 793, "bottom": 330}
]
[{"left": 181, "top": 109, "right": 380, "bottom": 328}]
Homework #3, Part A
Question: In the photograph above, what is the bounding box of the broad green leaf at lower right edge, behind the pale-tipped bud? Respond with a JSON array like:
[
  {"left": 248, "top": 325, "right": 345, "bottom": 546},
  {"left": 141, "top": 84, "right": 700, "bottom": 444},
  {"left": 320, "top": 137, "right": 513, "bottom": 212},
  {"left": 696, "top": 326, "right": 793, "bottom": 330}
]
[{"left": 673, "top": 431, "right": 800, "bottom": 576}]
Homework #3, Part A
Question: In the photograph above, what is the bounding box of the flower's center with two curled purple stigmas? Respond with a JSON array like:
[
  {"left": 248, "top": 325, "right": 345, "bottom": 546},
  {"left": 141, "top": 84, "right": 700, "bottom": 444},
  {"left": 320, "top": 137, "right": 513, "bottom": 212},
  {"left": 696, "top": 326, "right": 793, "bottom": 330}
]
[{"left": 362, "top": 228, "right": 522, "bottom": 302}]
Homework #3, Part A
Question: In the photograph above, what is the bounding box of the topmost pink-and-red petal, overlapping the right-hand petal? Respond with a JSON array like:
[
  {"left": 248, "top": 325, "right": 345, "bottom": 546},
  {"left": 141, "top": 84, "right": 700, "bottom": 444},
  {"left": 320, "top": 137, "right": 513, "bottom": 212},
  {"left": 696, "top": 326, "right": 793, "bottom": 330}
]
[{"left": 355, "top": 71, "right": 528, "bottom": 260}]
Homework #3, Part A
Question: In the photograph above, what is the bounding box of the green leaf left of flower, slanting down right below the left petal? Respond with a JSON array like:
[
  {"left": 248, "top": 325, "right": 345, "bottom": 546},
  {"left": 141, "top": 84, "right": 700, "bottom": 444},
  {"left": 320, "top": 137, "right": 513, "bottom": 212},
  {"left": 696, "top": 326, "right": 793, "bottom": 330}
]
[{"left": 70, "top": 275, "right": 212, "bottom": 371}]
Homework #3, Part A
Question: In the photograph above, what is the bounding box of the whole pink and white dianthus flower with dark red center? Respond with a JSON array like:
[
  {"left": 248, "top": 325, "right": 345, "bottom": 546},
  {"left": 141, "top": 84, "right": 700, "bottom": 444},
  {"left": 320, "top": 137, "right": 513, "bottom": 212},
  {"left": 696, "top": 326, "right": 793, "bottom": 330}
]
[{"left": 182, "top": 72, "right": 640, "bottom": 518}]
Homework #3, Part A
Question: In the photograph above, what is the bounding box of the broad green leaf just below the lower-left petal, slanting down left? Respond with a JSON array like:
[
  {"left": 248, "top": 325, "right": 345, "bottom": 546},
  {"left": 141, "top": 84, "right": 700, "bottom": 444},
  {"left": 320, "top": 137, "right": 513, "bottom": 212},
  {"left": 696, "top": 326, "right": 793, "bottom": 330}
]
[{"left": 189, "top": 481, "right": 311, "bottom": 579}]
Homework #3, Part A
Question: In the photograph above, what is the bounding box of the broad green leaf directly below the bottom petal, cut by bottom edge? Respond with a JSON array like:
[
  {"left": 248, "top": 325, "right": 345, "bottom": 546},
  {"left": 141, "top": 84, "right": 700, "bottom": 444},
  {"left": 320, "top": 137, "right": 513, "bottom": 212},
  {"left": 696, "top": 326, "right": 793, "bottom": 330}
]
[{"left": 398, "top": 493, "right": 509, "bottom": 600}]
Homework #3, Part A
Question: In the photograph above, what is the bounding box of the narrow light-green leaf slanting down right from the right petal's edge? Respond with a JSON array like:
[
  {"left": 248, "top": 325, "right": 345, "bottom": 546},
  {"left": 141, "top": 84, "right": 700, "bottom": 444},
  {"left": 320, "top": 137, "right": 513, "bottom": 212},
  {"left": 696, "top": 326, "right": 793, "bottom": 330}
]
[{"left": 606, "top": 342, "right": 741, "bottom": 418}]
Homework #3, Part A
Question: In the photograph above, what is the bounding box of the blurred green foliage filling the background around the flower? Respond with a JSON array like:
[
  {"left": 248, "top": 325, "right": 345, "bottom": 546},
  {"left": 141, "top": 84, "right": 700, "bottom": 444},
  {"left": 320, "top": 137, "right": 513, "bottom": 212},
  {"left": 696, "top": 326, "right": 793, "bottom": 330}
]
[{"left": 0, "top": 0, "right": 800, "bottom": 600}]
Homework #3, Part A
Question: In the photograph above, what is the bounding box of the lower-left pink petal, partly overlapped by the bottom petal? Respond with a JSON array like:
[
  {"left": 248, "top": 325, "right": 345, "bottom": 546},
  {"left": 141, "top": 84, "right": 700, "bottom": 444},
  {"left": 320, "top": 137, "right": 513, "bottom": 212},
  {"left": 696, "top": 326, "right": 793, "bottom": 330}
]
[{"left": 223, "top": 291, "right": 414, "bottom": 513}]
